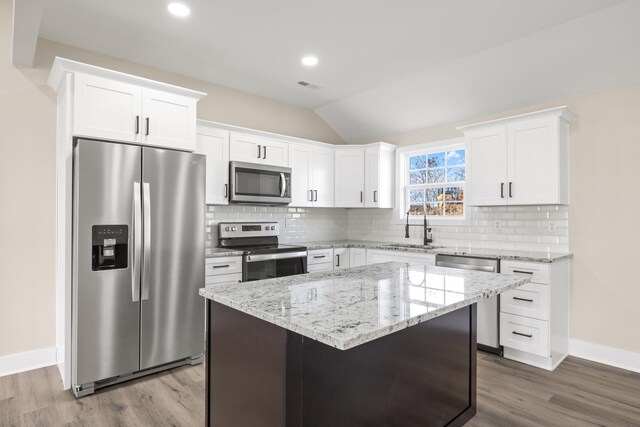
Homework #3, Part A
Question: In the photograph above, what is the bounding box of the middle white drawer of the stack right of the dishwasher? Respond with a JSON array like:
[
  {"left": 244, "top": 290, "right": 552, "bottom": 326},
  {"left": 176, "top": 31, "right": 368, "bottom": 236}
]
[{"left": 500, "top": 283, "right": 549, "bottom": 320}]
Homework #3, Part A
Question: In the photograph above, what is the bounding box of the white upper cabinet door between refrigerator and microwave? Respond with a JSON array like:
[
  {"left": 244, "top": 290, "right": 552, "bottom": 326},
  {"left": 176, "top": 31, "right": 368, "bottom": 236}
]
[{"left": 196, "top": 128, "right": 229, "bottom": 205}]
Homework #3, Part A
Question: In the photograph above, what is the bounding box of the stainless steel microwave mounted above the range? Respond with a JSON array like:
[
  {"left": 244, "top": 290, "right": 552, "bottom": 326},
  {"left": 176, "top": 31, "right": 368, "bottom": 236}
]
[{"left": 229, "top": 162, "right": 291, "bottom": 205}]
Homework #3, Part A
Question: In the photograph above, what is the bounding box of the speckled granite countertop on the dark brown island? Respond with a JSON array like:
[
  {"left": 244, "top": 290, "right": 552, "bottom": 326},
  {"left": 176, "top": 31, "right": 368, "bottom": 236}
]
[{"left": 200, "top": 262, "right": 531, "bottom": 350}]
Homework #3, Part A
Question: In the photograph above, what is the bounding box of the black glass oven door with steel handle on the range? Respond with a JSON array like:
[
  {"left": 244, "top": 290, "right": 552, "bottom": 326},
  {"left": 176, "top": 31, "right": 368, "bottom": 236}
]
[{"left": 242, "top": 251, "right": 307, "bottom": 282}]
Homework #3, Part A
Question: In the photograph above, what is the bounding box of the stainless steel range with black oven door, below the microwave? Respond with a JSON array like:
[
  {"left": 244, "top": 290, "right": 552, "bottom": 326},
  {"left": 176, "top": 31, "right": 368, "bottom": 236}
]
[{"left": 219, "top": 222, "right": 307, "bottom": 282}]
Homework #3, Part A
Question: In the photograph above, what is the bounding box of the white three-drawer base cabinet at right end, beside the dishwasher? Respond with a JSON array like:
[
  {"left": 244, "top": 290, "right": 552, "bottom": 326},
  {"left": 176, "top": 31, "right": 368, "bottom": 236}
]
[{"left": 500, "top": 260, "right": 569, "bottom": 370}]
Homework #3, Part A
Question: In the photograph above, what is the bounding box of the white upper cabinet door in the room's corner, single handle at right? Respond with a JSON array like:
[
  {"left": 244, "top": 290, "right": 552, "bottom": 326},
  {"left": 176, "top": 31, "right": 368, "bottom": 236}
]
[{"left": 335, "top": 147, "right": 364, "bottom": 208}]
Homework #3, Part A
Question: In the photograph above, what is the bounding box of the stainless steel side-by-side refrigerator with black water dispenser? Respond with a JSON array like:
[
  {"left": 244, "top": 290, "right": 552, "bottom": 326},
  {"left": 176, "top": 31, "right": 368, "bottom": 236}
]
[{"left": 72, "top": 139, "right": 205, "bottom": 396}]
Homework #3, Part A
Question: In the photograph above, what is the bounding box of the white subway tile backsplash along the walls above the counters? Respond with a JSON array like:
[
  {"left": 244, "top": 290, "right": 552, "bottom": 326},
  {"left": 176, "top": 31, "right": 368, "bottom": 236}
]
[{"left": 206, "top": 205, "right": 569, "bottom": 252}]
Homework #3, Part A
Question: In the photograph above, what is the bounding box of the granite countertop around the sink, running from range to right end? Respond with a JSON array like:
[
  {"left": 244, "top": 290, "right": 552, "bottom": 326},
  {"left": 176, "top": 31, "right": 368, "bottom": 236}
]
[{"left": 296, "top": 240, "right": 573, "bottom": 263}]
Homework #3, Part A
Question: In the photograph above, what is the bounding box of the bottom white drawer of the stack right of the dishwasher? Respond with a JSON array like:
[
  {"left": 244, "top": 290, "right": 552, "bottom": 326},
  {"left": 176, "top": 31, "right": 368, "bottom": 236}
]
[{"left": 500, "top": 313, "right": 550, "bottom": 357}]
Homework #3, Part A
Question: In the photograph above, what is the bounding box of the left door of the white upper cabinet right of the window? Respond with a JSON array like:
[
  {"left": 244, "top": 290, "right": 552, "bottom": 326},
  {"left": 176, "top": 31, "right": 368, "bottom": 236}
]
[{"left": 467, "top": 126, "right": 508, "bottom": 206}]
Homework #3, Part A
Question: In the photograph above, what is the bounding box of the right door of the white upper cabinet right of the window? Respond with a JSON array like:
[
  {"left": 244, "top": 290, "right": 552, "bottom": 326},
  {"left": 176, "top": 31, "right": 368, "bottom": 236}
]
[{"left": 507, "top": 118, "right": 560, "bottom": 205}]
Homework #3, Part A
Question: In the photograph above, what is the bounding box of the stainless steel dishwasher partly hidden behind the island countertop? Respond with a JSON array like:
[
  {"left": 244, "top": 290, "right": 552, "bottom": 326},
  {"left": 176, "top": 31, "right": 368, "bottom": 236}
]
[{"left": 436, "top": 254, "right": 503, "bottom": 356}]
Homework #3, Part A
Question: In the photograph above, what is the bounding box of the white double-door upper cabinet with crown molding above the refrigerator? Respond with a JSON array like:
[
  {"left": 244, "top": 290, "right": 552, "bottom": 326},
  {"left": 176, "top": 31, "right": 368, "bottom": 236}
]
[{"left": 49, "top": 58, "right": 205, "bottom": 151}]
